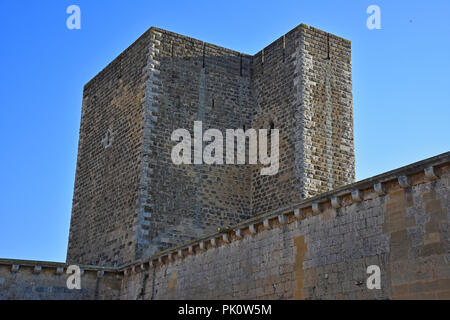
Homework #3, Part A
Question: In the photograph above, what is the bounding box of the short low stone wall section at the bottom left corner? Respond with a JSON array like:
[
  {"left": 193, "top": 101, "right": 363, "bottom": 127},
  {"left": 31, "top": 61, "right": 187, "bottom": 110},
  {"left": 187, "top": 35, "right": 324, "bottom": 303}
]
[{"left": 0, "top": 259, "right": 121, "bottom": 300}]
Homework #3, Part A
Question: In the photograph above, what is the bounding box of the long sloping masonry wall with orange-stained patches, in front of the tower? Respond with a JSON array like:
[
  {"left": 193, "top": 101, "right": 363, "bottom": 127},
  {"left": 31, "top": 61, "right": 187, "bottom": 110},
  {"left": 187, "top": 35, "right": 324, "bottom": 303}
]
[{"left": 121, "top": 153, "right": 450, "bottom": 299}]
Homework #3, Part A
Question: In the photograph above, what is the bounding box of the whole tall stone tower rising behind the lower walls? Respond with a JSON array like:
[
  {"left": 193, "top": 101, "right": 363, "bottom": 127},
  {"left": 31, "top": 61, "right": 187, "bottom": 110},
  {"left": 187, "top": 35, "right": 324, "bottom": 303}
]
[{"left": 67, "top": 24, "right": 355, "bottom": 266}]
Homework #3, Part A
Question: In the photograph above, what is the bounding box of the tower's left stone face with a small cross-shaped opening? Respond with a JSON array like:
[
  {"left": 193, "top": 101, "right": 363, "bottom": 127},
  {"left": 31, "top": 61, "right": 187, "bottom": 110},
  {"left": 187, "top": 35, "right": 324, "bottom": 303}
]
[{"left": 67, "top": 32, "right": 150, "bottom": 266}]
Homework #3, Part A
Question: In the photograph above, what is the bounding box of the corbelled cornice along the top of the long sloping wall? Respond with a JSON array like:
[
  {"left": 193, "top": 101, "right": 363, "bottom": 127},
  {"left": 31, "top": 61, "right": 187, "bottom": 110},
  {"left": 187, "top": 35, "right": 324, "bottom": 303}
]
[{"left": 119, "top": 152, "right": 450, "bottom": 275}]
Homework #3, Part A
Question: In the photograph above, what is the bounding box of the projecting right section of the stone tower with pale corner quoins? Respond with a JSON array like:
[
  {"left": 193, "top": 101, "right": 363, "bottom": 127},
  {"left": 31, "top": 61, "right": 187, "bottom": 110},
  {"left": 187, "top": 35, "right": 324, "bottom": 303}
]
[{"left": 251, "top": 25, "right": 355, "bottom": 214}]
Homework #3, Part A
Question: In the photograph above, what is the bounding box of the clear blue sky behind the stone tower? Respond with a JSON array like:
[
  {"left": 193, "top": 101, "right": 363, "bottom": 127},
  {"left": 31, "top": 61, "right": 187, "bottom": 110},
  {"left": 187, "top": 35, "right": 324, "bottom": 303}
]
[{"left": 0, "top": 0, "right": 450, "bottom": 261}]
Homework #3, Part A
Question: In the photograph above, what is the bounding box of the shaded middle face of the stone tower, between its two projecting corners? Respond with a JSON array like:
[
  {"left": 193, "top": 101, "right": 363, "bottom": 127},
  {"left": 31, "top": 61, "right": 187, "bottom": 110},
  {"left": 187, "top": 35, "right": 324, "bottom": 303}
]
[{"left": 142, "top": 28, "right": 254, "bottom": 257}]
